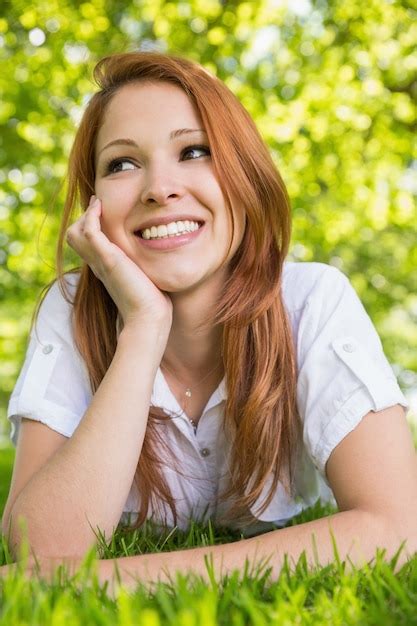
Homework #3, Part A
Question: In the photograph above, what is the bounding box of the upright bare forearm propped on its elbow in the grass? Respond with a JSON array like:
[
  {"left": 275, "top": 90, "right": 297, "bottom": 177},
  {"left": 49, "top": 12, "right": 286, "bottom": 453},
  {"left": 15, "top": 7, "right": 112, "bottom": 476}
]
[{"left": 6, "top": 322, "right": 163, "bottom": 556}]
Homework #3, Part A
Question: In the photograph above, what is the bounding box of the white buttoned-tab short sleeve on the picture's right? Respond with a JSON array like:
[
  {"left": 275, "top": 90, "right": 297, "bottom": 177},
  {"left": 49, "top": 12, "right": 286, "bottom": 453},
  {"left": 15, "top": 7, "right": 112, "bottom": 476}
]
[{"left": 297, "top": 264, "right": 409, "bottom": 485}]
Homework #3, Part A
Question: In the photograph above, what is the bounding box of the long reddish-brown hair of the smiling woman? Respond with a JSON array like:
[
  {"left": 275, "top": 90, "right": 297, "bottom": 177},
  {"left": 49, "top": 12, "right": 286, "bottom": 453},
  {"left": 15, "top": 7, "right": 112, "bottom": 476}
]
[{"left": 34, "top": 52, "right": 301, "bottom": 530}]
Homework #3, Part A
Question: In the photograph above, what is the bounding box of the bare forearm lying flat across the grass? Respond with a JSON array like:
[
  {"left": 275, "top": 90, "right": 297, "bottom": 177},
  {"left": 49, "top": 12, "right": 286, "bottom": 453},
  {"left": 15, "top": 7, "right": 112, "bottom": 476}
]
[{"left": 99, "top": 504, "right": 417, "bottom": 589}]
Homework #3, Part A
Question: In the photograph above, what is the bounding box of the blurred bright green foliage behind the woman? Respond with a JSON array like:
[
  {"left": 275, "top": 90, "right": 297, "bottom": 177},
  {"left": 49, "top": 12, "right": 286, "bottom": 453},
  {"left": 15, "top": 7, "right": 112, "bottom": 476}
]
[{"left": 0, "top": 0, "right": 417, "bottom": 432}]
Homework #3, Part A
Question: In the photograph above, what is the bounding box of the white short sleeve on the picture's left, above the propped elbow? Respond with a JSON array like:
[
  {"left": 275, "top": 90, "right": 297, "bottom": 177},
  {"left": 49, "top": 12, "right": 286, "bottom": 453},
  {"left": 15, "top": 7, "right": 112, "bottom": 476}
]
[{"left": 7, "top": 274, "right": 92, "bottom": 446}]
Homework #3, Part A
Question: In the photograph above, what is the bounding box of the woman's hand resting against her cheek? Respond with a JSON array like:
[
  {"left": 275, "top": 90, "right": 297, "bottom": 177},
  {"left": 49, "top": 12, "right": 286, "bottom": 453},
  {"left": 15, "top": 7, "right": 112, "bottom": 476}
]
[{"left": 66, "top": 196, "right": 172, "bottom": 337}]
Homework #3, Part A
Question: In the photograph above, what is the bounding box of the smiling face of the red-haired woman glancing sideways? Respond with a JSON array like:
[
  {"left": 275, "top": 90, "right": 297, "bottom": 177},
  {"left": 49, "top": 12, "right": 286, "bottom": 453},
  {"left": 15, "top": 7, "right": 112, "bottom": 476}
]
[{"left": 95, "top": 82, "right": 246, "bottom": 292}]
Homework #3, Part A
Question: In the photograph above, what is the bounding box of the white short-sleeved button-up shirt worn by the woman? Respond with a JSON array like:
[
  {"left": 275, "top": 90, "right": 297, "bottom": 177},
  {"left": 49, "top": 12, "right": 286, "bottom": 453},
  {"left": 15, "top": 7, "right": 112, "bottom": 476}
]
[{"left": 7, "top": 261, "right": 409, "bottom": 536}]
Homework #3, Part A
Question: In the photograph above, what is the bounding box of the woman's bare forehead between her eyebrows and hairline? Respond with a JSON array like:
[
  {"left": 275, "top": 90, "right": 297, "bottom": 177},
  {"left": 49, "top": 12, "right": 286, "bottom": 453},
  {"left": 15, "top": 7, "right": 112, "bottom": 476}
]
[{"left": 97, "top": 82, "right": 201, "bottom": 147}]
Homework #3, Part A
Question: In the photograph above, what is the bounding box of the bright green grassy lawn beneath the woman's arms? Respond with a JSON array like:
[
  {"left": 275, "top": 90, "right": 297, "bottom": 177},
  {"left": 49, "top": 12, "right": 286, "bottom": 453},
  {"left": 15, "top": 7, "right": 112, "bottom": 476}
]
[{"left": 0, "top": 427, "right": 417, "bottom": 626}]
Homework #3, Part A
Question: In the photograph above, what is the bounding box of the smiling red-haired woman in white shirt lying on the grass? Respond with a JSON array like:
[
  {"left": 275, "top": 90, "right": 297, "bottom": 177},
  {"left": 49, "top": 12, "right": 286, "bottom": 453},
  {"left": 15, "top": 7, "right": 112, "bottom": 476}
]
[{"left": 3, "top": 52, "right": 417, "bottom": 582}]
